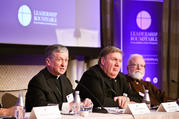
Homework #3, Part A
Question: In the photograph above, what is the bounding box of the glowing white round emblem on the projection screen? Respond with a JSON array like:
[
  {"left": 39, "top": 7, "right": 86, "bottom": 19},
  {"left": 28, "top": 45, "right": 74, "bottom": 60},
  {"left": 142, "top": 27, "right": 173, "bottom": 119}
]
[{"left": 18, "top": 5, "right": 32, "bottom": 26}]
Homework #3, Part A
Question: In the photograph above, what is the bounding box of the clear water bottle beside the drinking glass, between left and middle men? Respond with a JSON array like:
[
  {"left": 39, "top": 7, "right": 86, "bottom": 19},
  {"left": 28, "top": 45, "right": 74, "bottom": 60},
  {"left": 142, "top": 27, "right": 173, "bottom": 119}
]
[{"left": 73, "top": 91, "right": 81, "bottom": 115}]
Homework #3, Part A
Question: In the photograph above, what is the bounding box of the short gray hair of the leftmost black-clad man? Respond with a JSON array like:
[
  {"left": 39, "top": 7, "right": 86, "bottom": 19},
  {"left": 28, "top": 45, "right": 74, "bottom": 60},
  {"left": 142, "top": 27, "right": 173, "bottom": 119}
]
[{"left": 45, "top": 44, "right": 68, "bottom": 58}]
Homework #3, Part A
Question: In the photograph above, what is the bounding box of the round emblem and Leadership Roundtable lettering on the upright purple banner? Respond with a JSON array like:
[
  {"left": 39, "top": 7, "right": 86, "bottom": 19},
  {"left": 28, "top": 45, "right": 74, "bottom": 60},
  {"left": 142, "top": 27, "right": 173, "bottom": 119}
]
[{"left": 130, "top": 10, "right": 158, "bottom": 45}]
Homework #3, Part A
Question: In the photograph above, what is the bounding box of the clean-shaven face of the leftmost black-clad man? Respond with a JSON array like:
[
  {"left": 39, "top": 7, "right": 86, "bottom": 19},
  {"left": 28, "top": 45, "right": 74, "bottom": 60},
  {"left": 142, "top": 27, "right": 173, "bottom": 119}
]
[{"left": 46, "top": 52, "right": 68, "bottom": 76}]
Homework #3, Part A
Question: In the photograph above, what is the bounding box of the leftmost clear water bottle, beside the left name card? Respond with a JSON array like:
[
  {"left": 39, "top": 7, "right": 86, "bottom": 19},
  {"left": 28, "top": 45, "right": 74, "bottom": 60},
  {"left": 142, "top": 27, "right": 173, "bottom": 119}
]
[{"left": 15, "top": 93, "right": 25, "bottom": 119}]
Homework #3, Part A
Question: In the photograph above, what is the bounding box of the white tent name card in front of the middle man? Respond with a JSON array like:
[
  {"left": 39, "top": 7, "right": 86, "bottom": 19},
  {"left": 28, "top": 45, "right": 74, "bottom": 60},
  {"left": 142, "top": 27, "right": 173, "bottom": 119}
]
[{"left": 124, "top": 103, "right": 150, "bottom": 115}]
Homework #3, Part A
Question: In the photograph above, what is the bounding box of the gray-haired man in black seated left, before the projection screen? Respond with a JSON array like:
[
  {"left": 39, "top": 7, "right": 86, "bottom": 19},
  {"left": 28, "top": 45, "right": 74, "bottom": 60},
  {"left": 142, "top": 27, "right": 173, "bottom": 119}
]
[{"left": 25, "top": 44, "right": 91, "bottom": 112}]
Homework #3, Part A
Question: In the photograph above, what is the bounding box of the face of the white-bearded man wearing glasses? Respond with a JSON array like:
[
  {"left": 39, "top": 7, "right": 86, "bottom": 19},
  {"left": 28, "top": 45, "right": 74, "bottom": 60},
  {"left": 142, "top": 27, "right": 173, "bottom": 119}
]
[{"left": 127, "top": 56, "right": 145, "bottom": 80}]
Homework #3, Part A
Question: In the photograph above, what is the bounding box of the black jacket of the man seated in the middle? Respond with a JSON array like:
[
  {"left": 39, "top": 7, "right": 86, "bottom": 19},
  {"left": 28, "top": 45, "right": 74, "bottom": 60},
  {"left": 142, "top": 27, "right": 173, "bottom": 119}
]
[{"left": 76, "top": 65, "right": 141, "bottom": 107}]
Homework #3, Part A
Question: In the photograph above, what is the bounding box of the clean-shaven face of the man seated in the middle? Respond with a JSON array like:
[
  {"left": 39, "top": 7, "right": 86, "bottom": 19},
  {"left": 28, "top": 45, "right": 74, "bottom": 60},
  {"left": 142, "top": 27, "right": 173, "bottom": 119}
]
[{"left": 101, "top": 52, "right": 122, "bottom": 78}]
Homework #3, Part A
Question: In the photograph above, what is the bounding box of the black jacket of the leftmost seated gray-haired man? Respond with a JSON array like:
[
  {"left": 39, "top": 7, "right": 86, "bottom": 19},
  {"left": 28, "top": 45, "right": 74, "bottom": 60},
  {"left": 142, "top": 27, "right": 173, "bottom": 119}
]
[{"left": 25, "top": 68, "right": 73, "bottom": 112}]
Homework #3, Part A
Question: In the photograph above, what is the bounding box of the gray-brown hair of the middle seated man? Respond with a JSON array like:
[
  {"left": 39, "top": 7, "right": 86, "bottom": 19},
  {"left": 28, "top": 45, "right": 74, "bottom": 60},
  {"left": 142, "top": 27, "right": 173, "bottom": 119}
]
[{"left": 98, "top": 46, "right": 122, "bottom": 64}]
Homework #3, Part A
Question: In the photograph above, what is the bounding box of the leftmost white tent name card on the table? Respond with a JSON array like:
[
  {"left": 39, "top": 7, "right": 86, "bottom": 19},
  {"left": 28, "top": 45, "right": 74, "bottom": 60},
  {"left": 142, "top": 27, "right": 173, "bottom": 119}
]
[{"left": 29, "top": 105, "right": 61, "bottom": 119}]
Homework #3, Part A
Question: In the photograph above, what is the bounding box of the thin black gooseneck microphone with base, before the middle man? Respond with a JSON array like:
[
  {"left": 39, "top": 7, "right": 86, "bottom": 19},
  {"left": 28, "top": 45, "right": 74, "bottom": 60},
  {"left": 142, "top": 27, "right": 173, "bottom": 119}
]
[{"left": 75, "top": 80, "right": 108, "bottom": 113}]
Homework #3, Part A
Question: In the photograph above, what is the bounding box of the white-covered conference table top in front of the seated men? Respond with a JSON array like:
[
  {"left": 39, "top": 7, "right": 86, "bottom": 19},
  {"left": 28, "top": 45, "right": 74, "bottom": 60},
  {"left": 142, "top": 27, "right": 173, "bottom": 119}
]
[{"left": 25, "top": 110, "right": 179, "bottom": 119}]
